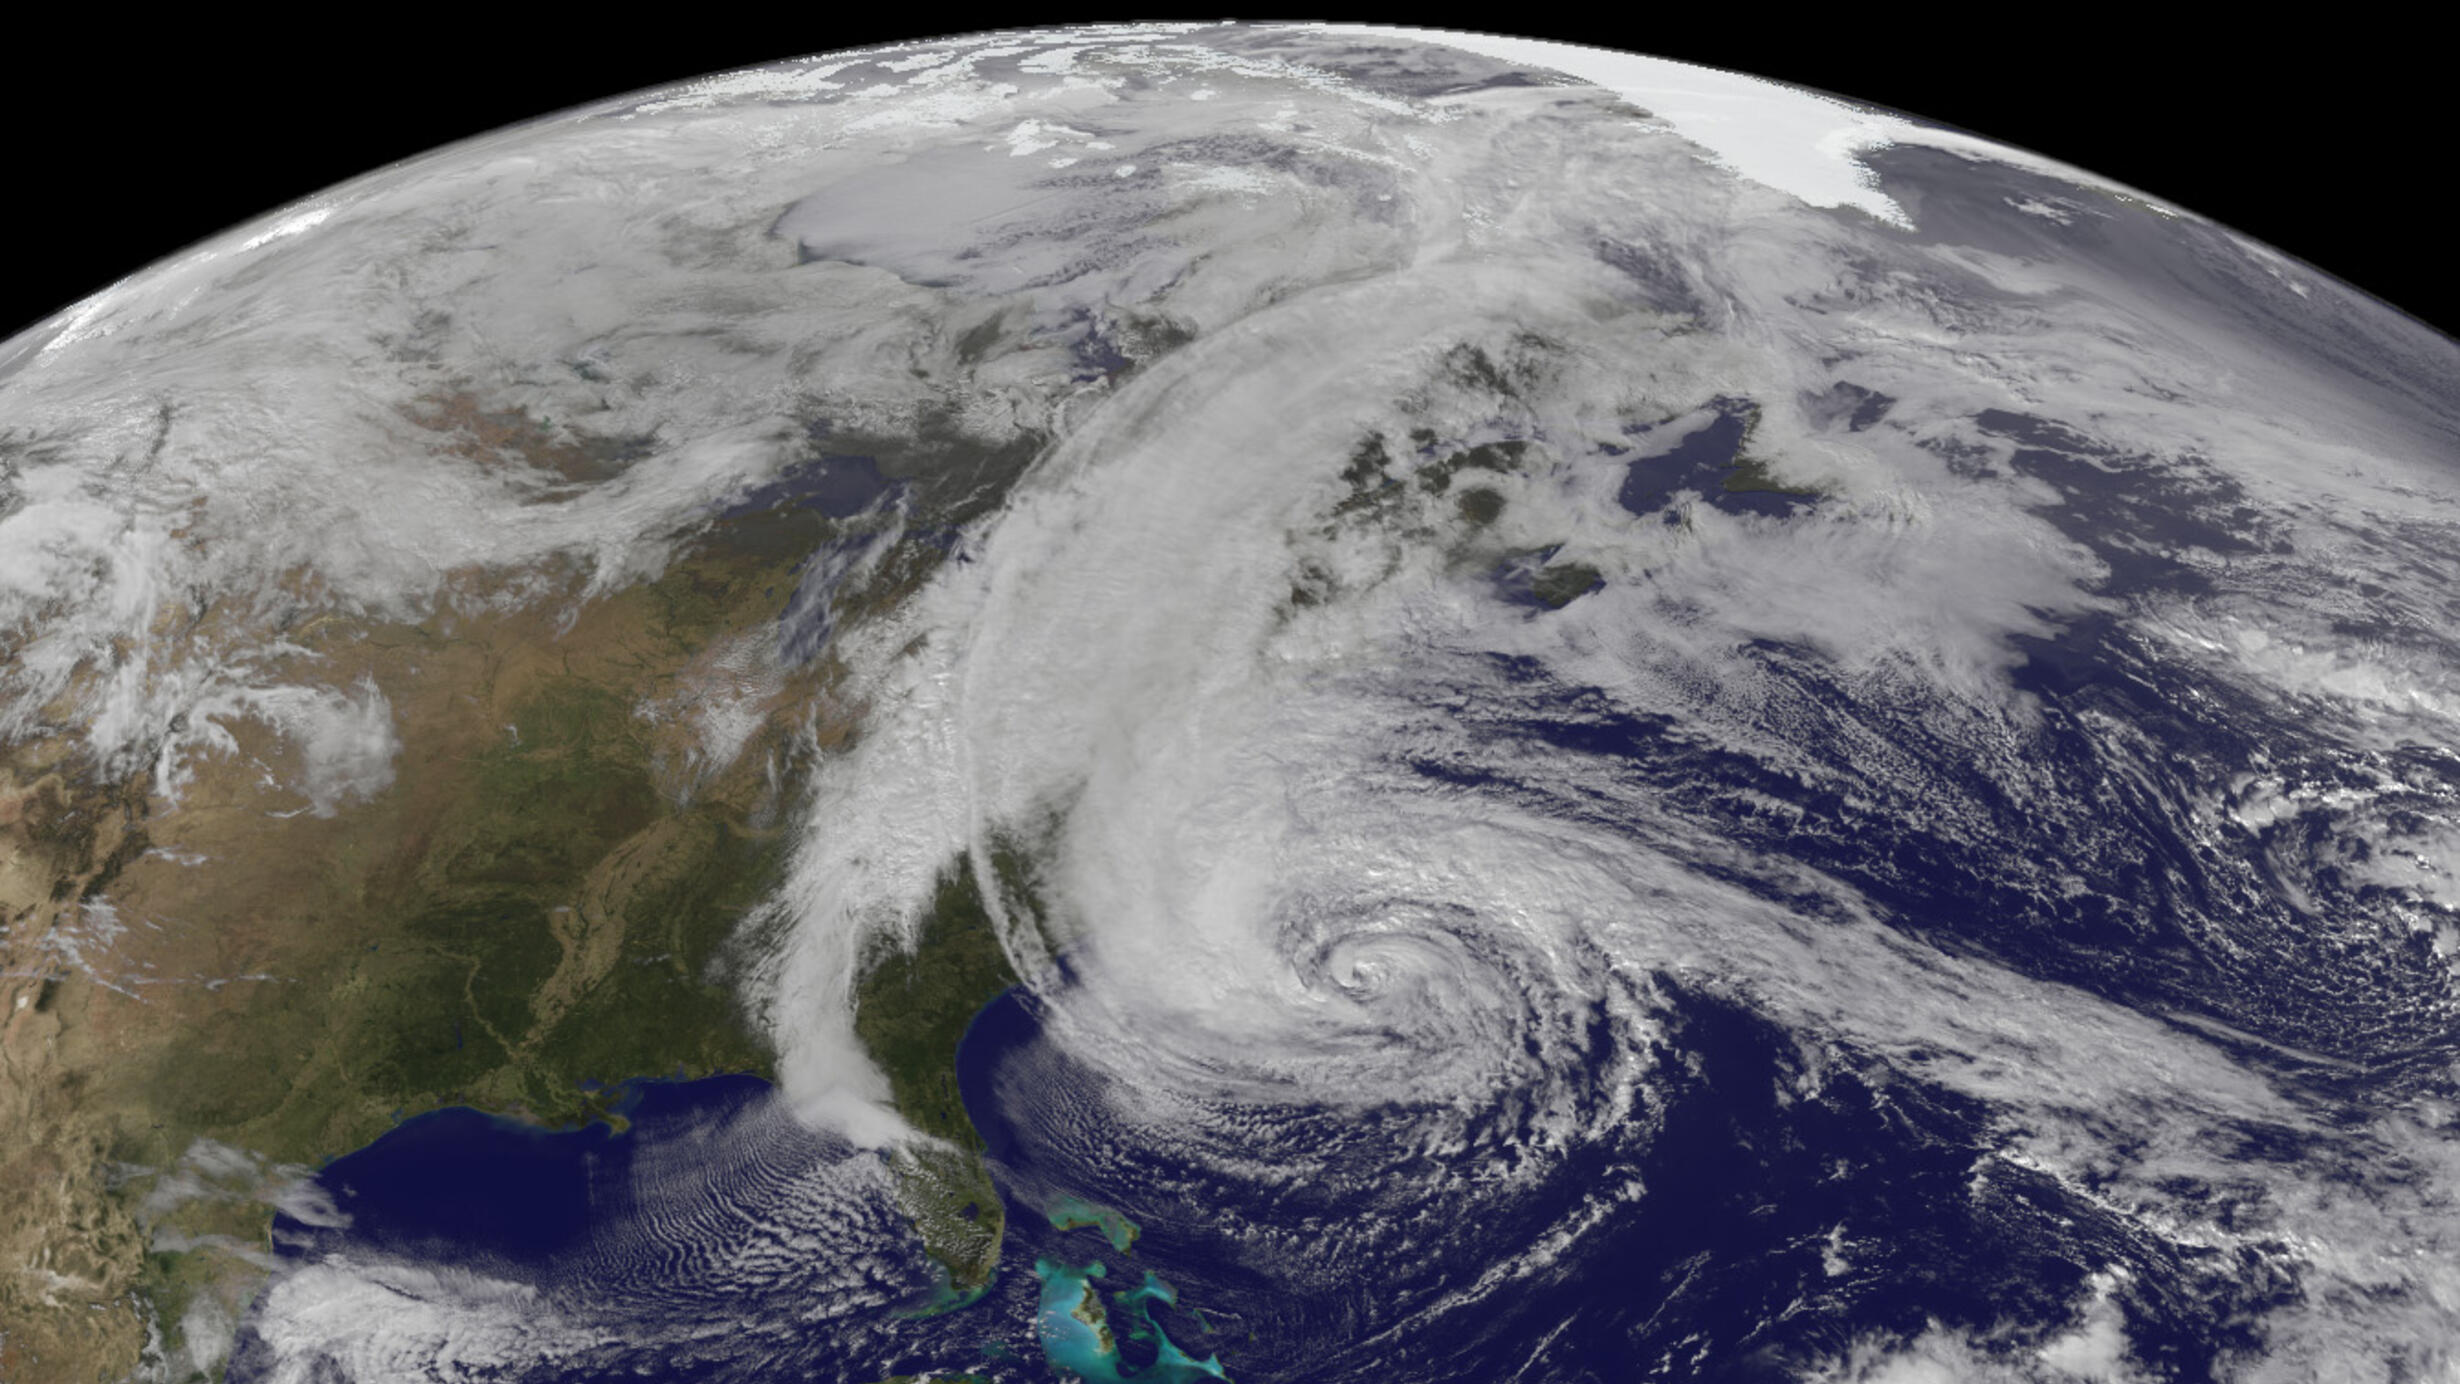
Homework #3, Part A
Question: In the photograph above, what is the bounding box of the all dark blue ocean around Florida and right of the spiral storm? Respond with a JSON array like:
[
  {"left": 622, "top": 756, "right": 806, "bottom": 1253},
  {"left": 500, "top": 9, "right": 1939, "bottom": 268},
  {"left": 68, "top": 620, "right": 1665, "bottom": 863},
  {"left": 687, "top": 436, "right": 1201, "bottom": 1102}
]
[{"left": 231, "top": 594, "right": 2305, "bottom": 1384}]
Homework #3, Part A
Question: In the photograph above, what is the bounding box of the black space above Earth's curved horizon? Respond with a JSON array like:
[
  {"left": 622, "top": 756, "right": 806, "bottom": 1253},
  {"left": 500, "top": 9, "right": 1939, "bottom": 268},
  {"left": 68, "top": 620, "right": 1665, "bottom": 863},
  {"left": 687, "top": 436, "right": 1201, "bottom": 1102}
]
[{"left": 0, "top": 18, "right": 2460, "bottom": 339}]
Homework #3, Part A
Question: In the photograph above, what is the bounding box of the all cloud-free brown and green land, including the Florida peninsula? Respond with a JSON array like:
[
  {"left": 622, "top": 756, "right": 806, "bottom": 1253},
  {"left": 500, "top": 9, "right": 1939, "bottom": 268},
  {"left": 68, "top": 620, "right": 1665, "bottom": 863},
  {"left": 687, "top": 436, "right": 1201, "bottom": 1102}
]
[{"left": 0, "top": 396, "right": 1077, "bottom": 1377}]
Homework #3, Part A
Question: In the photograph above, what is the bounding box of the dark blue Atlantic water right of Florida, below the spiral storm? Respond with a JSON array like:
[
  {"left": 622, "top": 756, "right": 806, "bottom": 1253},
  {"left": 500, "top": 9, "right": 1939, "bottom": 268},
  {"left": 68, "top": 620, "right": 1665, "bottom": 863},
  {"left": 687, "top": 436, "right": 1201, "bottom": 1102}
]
[{"left": 944, "top": 978, "right": 2258, "bottom": 1384}]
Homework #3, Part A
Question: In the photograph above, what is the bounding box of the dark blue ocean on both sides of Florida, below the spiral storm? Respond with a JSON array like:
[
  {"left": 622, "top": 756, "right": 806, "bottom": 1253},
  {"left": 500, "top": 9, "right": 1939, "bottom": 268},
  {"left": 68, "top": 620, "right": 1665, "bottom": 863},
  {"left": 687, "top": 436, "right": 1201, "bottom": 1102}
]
[{"left": 231, "top": 953, "right": 2282, "bottom": 1384}]
